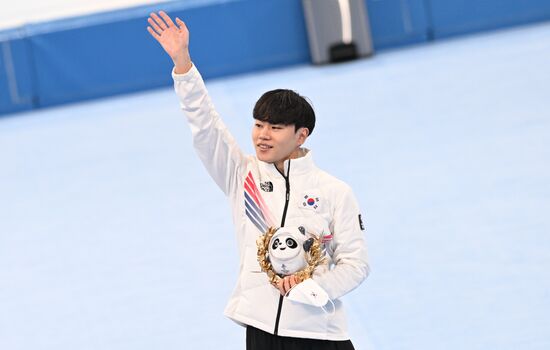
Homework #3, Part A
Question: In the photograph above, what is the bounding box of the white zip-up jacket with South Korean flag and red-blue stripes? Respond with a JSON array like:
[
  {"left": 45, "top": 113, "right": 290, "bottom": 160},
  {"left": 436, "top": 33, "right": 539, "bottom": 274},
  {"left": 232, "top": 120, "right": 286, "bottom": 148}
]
[{"left": 172, "top": 66, "right": 369, "bottom": 340}]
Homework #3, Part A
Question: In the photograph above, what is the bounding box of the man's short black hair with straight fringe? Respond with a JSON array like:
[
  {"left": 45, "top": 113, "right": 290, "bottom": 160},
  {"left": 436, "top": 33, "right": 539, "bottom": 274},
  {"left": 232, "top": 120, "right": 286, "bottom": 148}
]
[{"left": 253, "top": 89, "right": 315, "bottom": 135}]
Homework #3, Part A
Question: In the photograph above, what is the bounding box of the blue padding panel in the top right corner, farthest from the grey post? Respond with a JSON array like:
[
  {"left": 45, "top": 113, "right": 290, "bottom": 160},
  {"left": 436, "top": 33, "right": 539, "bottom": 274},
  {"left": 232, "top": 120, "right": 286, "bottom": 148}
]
[{"left": 429, "top": 0, "right": 550, "bottom": 38}]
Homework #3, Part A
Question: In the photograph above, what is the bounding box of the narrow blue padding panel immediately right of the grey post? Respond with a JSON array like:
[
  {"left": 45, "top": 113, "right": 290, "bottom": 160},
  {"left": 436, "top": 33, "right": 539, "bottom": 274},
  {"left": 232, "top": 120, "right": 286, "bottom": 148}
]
[{"left": 365, "top": 0, "right": 429, "bottom": 49}]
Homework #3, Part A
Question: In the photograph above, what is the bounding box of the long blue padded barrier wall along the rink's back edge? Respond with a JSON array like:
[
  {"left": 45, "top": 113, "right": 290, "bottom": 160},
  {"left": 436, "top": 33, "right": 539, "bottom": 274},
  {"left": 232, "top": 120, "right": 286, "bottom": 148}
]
[{"left": 0, "top": 0, "right": 550, "bottom": 115}]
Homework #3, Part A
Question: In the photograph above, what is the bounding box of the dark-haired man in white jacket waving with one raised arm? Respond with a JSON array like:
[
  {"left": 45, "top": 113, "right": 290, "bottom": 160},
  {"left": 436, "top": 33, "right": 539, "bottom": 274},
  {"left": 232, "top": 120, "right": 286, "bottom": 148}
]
[{"left": 147, "top": 11, "right": 369, "bottom": 350}]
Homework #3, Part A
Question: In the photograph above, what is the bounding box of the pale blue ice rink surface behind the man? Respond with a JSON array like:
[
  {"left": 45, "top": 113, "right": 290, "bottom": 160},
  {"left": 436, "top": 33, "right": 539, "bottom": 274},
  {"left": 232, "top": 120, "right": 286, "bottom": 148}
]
[{"left": 0, "top": 23, "right": 550, "bottom": 350}]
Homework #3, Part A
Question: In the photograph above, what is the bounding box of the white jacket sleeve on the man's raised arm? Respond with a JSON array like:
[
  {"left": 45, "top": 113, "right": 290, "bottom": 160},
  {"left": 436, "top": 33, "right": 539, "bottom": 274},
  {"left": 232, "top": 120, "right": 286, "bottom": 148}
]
[{"left": 172, "top": 65, "right": 246, "bottom": 195}]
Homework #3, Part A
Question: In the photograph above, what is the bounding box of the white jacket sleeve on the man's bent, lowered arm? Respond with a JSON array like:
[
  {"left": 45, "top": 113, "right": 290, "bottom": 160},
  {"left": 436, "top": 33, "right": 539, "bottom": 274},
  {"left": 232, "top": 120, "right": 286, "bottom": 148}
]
[{"left": 313, "top": 186, "right": 370, "bottom": 300}]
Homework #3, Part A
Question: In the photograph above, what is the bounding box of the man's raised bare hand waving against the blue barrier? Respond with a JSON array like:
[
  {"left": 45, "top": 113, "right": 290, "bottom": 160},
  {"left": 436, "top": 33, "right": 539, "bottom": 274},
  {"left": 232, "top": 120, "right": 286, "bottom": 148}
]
[{"left": 147, "top": 11, "right": 192, "bottom": 74}]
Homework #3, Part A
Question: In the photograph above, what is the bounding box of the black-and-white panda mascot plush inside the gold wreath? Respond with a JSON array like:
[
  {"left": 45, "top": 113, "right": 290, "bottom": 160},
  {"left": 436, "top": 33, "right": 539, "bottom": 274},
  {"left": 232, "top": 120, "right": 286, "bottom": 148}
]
[{"left": 268, "top": 226, "right": 314, "bottom": 276}]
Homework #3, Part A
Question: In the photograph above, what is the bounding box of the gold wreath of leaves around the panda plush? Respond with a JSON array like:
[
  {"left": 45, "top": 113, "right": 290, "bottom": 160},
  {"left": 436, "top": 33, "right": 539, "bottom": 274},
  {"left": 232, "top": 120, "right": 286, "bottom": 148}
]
[{"left": 256, "top": 227, "right": 325, "bottom": 285}]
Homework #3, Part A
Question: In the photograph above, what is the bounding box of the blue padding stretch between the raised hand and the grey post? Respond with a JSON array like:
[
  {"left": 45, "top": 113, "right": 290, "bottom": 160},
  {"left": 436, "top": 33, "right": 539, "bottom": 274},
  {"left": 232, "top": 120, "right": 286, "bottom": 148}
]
[{"left": 184, "top": 0, "right": 310, "bottom": 78}]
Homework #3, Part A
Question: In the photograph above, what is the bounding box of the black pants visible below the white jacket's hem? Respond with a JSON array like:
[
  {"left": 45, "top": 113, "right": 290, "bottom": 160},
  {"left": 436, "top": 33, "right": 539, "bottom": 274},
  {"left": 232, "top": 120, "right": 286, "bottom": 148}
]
[{"left": 246, "top": 326, "right": 355, "bottom": 350}]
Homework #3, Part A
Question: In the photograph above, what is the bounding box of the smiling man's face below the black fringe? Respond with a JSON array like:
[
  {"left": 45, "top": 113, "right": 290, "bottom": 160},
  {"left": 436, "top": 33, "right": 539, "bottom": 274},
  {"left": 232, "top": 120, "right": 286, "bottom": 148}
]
[{"left": 252, "top": 120, "right": 308, "bottom": 165}]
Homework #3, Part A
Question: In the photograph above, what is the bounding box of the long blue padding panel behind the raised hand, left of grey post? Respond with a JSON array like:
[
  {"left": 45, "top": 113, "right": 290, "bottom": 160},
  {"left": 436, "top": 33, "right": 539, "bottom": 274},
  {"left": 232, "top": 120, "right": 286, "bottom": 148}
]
[{"left": 28, "top": 0, "right": 309, "bottom": 106}]
